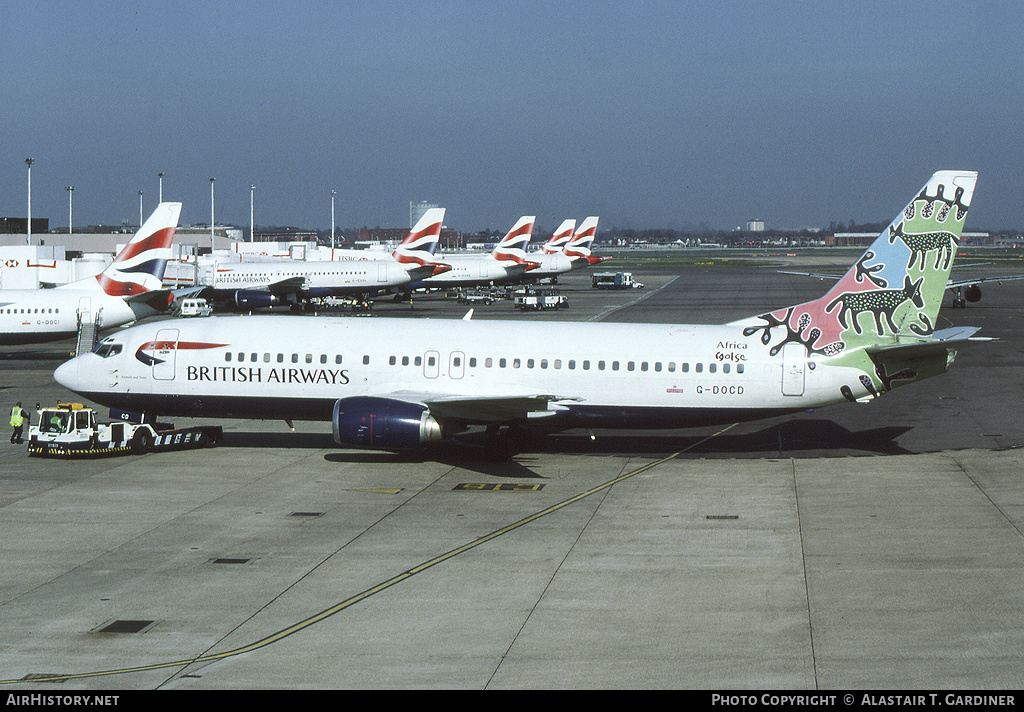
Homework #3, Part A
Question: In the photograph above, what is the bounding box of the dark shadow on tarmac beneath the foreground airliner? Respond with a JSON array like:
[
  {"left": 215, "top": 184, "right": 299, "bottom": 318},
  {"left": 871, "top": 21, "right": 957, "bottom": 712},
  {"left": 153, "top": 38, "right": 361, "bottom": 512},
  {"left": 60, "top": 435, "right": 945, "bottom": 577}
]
[{"left": 220, "top": 420, "right": 913, "bottom": 477}]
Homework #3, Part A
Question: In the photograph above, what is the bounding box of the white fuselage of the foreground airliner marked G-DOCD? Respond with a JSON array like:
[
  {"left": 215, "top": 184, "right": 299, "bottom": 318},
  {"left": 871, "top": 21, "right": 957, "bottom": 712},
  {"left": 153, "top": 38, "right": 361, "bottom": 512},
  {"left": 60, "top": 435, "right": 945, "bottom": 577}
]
[{"left": 55, "top": 316, "right": 865, "bottom": 428}]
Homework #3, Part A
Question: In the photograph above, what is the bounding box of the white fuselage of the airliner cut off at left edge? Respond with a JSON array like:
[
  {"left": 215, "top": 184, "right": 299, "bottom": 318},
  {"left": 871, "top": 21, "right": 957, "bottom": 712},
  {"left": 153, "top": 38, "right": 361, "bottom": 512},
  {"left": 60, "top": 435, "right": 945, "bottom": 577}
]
[{"left": 0, "top": 283, "right": 135, "bottom": 344}]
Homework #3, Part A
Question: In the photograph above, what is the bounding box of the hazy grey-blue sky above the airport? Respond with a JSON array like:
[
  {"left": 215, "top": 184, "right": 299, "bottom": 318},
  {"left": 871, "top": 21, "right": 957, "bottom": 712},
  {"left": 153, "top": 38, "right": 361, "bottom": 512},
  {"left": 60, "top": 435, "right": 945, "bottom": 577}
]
[{"left": 0, "top": 0, "right": 1024, "bottom": 232}]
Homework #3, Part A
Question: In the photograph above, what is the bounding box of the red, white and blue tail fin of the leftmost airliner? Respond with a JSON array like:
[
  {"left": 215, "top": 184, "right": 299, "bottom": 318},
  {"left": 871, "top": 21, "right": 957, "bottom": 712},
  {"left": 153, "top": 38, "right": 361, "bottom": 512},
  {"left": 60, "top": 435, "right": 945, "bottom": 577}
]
[{"left": 80, "top": 203, "right": 181, "bottom": 297}]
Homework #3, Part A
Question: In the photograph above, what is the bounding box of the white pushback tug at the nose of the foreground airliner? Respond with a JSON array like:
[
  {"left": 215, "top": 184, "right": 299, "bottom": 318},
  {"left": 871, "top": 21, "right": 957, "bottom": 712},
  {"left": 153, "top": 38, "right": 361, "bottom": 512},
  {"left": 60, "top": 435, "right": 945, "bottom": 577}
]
[{"left": 29, "top": 403, "right": 223, "bottom": 457}]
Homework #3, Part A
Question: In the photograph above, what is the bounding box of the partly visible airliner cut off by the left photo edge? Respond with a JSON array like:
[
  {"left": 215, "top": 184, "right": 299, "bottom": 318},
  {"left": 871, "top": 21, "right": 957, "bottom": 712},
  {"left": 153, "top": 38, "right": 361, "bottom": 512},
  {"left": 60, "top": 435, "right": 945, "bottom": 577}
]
[{"left": 0, "top": 203, "right": 181, "bottom": 344}]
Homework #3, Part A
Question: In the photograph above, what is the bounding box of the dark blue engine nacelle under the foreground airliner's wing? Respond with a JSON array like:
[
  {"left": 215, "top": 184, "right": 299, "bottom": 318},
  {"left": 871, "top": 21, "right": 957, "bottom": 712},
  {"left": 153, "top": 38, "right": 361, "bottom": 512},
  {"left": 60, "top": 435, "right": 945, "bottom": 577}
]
[{"left": 331, "top": 395, "right": 442, "bottom": 450}]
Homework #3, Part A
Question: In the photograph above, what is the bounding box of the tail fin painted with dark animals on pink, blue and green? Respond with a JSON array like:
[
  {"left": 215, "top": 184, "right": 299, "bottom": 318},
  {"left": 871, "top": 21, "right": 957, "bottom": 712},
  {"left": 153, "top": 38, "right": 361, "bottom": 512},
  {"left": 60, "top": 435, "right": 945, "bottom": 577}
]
[{"left": 736, "top": 171, "right": 978, "bottom": 355}]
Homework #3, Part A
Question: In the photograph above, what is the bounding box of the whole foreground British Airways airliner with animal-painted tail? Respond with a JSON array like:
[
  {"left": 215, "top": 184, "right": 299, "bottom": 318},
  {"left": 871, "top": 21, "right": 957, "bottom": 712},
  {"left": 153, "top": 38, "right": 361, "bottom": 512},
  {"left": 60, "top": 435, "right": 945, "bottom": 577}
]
[{"left": 55, "top": 171, "right": 977, "bottom": 450}]
